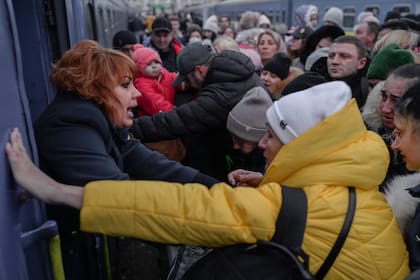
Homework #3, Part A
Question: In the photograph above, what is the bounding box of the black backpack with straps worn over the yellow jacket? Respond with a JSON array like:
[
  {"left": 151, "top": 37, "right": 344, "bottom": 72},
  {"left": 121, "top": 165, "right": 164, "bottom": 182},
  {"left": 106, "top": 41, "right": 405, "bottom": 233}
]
[{"left": 182, "top": 186, "right": 356, "bottom": 280}]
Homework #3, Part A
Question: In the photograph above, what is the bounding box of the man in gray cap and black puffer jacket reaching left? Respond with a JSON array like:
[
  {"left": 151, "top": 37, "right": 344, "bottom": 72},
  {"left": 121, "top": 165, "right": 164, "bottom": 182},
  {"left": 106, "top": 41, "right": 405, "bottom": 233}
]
[{"left": 131, "top": 43, "right": 264, "bottom": 180}]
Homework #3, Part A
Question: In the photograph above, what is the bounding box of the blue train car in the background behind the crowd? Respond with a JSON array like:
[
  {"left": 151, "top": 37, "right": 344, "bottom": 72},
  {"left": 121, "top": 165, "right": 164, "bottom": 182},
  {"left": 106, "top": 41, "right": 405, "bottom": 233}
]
[{"left": 184, "top": 0, "right": 420, "bottom": 31}]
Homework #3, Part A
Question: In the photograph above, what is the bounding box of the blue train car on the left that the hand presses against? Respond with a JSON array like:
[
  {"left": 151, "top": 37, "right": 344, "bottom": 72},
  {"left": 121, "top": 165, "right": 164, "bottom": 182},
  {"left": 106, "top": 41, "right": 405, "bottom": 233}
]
[{"left": 0, "top": 0, "right": 133, "bottom": 280}]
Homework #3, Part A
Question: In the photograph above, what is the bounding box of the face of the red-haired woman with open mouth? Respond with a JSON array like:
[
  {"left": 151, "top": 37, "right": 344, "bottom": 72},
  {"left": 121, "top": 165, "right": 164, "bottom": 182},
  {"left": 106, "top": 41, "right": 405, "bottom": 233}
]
[{"left": 111, "top": 75, "right": 141, "bottom": 128}]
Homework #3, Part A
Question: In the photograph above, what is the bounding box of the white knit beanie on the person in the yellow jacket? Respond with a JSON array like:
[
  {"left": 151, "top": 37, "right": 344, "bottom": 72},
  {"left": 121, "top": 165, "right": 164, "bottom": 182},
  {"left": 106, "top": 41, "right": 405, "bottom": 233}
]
[{"left": 267, "top": 81, "right": 351, "bottom": 144}]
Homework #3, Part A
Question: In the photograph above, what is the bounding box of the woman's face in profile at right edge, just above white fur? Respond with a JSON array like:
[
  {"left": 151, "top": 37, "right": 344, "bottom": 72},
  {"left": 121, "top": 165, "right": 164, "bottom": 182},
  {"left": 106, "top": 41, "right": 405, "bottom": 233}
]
[{"left": 391, "top": 114, "right": 420, "bottom": 171}]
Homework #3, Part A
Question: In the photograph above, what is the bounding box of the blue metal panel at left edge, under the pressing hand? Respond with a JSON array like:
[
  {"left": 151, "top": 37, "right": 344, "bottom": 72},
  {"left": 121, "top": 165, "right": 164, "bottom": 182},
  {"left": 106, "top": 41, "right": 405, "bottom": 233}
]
[{"left": 0, "top": 0, "right": 52, "bottom": 280}]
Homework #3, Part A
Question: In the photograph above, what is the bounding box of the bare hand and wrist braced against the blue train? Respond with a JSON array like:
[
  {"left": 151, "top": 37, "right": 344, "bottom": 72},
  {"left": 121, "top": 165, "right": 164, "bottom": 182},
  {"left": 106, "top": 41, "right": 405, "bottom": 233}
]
[{"left": 6, "top": 128, "right": 83, "bottom": 209}]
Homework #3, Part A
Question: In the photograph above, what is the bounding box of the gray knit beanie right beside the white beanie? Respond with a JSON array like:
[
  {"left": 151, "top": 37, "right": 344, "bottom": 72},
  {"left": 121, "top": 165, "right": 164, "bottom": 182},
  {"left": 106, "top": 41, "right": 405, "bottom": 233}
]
[{"left": 226, "top": 87, "right": 273, "bottom": 142}]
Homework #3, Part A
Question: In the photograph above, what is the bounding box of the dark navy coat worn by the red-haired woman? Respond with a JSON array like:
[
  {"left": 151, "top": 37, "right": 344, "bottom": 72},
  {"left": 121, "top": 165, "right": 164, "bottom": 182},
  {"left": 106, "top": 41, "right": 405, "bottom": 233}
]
[{"left": 35, "top": 93, "right": 215, "bottom": 279}]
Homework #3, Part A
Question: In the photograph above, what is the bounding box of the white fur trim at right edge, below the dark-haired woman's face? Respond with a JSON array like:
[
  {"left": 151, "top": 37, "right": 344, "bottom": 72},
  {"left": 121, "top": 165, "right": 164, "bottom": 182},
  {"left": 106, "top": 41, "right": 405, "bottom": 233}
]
[{"left": 385, "top": 172, "right": 420, "bottom": 232}]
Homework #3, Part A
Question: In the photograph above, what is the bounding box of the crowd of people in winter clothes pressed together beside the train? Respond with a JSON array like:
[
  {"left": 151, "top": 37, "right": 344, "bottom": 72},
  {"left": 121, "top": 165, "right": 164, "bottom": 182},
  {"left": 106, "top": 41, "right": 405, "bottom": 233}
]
[{"left": 6, "top": 5, "right": 420, "bottom": 279}]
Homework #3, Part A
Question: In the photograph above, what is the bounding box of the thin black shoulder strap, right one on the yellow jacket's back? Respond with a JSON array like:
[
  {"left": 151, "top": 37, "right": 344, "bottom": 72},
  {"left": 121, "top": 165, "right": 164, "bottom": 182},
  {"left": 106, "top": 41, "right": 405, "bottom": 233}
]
[{"left": 315, "top": 187, "right": 356, "bottom": 279}]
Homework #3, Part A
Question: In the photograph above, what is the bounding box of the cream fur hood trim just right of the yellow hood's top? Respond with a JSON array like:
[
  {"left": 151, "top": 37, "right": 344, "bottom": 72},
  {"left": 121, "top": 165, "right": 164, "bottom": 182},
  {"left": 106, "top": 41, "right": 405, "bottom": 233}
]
[{"left": 362, "top": 81, "right": 385, "bottom": 132}]
